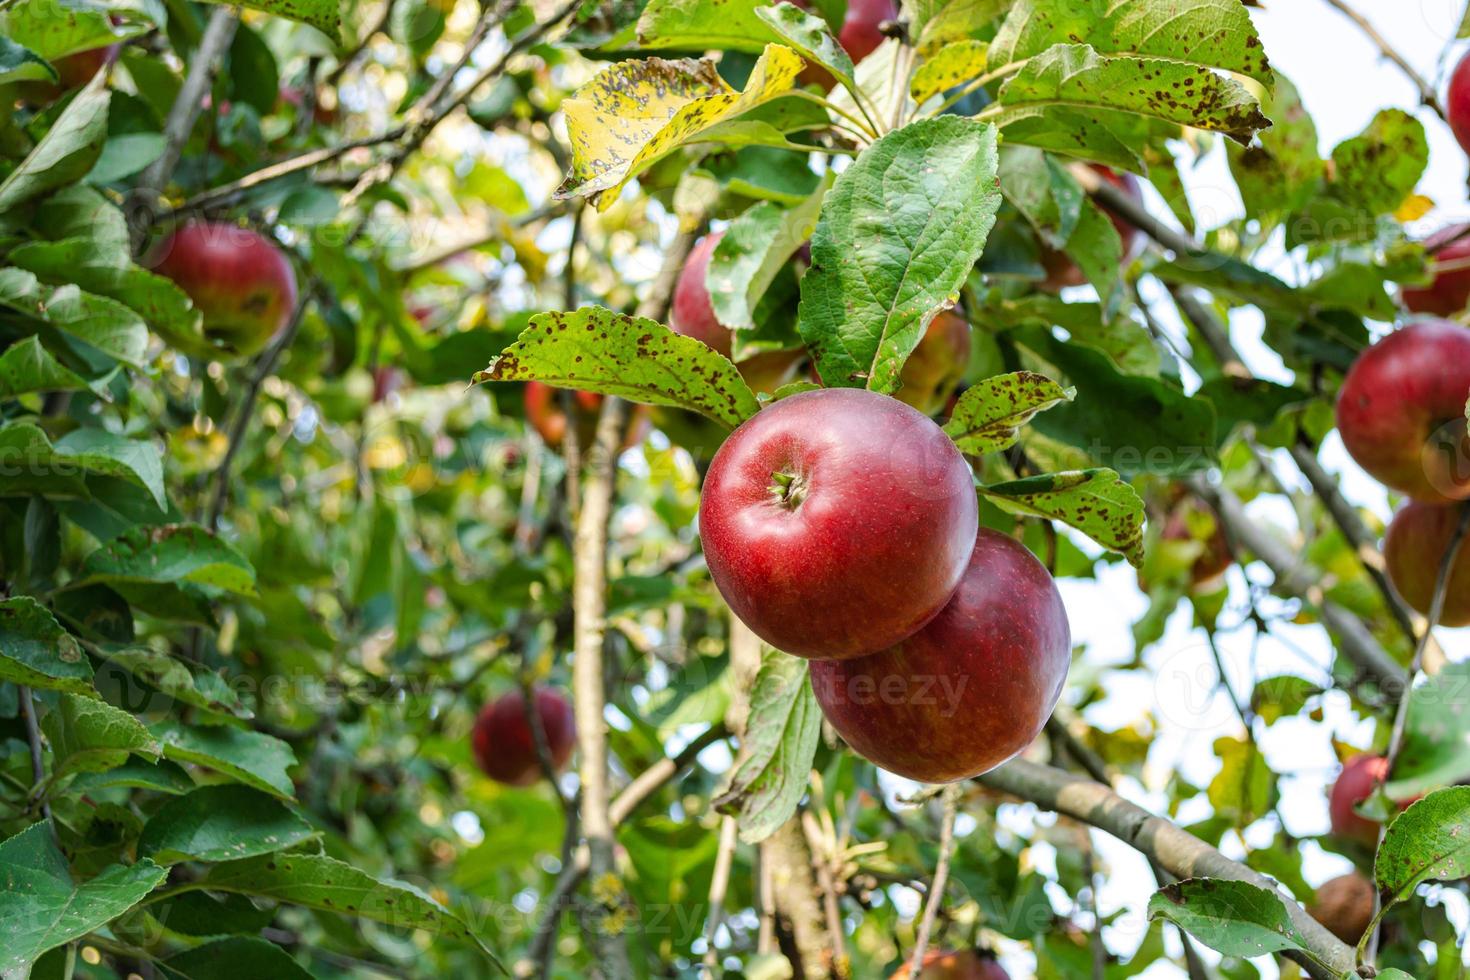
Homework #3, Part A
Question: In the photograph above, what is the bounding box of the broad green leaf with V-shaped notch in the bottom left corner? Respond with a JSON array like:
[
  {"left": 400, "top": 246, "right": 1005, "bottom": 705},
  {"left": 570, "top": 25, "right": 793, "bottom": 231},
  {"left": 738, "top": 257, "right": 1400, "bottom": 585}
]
[{"left": 0, "top": 823, "right": 168, "bottom": 977}]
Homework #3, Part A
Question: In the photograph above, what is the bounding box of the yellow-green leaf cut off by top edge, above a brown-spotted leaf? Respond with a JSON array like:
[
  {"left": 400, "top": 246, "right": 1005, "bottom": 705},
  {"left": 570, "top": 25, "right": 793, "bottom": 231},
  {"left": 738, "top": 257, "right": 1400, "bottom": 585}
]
[{"left": 989, "top": 0, "right": 1274, "bottom": 88}]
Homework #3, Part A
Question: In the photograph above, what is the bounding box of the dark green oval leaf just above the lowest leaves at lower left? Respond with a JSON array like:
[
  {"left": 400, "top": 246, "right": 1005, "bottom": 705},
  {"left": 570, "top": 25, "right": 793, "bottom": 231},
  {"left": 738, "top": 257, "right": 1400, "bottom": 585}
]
[{"left": 138, "top": 785, "right": 316, "bottom": 864}]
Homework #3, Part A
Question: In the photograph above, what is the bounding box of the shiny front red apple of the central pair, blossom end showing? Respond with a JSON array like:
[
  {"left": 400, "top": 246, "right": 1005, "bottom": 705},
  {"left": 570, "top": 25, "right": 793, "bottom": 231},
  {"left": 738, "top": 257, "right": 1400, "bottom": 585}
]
[{"left": 700, "top": 388, "right": 979, "bottom": 658}]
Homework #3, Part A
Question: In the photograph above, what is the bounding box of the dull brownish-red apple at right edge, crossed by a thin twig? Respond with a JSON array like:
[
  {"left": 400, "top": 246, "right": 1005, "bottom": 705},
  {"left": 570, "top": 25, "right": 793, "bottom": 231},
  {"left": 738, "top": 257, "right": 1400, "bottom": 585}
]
[{"left": 1383, "top": 501, "right": 1470, "bottom": 627}]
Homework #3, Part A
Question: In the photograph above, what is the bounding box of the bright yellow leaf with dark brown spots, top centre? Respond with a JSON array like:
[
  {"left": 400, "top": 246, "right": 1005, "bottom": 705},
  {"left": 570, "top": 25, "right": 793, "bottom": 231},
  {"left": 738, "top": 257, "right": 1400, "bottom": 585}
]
[{"left": 557, "top": 44, "right": 804, "bottom": 210}]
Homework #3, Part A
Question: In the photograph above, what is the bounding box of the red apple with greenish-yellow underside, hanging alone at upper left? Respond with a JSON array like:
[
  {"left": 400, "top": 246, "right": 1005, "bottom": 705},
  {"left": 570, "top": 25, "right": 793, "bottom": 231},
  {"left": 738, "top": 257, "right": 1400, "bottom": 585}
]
[{"left": 154, "top": 222, "right": 295, "bottom": 356}]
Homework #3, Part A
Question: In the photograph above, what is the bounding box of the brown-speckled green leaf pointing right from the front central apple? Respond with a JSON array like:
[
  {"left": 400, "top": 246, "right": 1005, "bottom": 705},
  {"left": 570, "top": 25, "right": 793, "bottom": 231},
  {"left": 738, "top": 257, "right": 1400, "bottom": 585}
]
[{"left": 979, "top": 469, "right": 1144, "bottom": 566}]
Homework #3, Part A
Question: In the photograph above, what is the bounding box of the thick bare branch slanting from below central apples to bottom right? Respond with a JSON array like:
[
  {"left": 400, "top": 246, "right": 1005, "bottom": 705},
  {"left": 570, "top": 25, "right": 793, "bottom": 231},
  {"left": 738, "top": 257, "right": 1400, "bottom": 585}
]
[{"left": 976, "top": 760, "right": 1354, "bottom": 977}]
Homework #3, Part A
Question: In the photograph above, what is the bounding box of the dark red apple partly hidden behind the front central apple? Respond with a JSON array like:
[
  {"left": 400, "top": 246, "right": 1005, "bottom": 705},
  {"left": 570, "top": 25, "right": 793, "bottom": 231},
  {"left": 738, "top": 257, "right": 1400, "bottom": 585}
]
[{"left": 811, "top": 529, "right": 1072, "bottom": 783}]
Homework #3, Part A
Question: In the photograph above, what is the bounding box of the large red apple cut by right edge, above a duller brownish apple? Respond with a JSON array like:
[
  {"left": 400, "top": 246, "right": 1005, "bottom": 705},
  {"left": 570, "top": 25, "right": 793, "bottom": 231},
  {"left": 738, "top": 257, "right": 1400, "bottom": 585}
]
[{"left": 1338, "top": 320, "right": 1470, "bottom": 502}]
